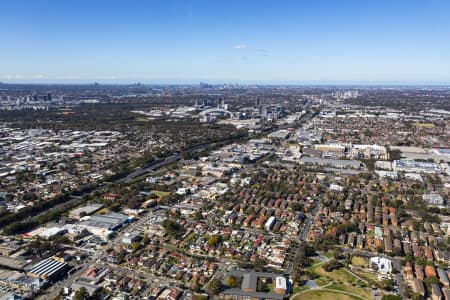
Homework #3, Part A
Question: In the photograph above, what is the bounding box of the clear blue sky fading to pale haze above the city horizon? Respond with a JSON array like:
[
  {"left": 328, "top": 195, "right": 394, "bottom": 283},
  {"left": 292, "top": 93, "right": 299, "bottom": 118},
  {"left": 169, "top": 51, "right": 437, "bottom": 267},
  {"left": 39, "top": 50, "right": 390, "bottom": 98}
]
[{"left": 0, "top": 0, "right": 450, "bottom": 84}]
